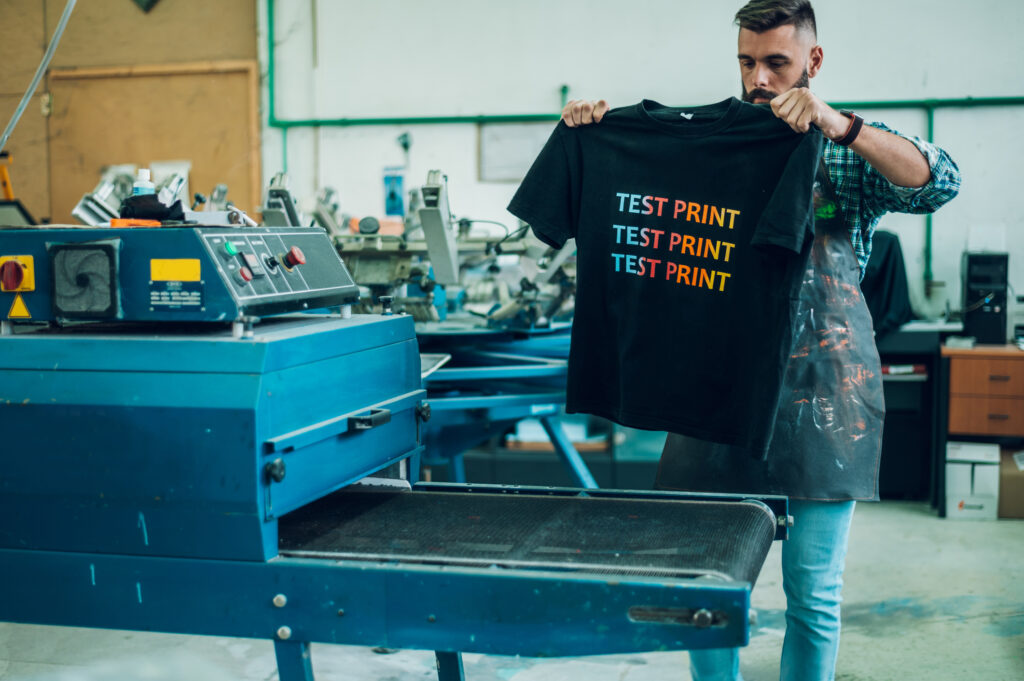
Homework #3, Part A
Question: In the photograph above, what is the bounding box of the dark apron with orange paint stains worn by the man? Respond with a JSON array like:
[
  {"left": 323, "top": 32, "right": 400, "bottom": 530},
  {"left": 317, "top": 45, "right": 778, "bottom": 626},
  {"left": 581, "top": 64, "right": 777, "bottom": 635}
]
[{"left": 654, "top": 162, "right": 885, "bottom": 500}]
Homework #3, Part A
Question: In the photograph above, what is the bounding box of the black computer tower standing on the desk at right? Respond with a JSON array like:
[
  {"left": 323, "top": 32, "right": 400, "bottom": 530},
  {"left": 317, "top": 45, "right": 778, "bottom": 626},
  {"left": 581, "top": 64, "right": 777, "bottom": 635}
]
[{"left": 961, "top": 253, "right": 1010, "bottom": 345}]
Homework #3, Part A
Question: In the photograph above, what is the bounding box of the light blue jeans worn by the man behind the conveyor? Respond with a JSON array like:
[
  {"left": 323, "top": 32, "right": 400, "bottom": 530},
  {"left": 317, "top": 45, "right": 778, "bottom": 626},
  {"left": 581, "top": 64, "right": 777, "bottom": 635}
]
[{"left": 690, "top": 500, "right": 856, "bottom": 681}]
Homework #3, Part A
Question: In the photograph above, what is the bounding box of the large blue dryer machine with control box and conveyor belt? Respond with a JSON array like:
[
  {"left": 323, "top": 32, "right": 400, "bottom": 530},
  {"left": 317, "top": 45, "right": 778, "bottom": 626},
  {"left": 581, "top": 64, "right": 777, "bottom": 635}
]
[{"left": 0, "top": 226, "right": 788, "bottom": 681}]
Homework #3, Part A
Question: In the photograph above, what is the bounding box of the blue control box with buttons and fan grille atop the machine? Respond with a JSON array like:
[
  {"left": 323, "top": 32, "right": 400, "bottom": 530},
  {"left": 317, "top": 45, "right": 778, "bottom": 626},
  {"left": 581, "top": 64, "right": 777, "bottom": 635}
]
[{"left": 0, "top": 226, "right": 358, "bottom": 322}]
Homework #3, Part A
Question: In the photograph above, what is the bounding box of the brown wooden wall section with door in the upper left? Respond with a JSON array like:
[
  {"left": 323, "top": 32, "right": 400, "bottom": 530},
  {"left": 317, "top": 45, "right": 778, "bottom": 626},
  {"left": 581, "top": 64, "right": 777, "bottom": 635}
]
[{"left": 0, "top": 0, "right": 260, "bottom": 222}]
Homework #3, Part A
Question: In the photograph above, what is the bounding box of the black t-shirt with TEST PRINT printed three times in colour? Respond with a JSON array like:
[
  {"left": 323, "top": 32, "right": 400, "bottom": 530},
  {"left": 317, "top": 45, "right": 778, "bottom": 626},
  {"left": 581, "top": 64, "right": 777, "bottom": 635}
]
[{"left": 509, "top": 98, "right": 821, "bottom": 456}]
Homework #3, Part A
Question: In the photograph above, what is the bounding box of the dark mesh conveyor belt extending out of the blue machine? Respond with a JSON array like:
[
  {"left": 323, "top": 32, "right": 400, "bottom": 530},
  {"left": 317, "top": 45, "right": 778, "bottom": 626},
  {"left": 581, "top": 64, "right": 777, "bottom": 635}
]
[{"left": 280, "top": 491, "right": 775, "bottom": 585}]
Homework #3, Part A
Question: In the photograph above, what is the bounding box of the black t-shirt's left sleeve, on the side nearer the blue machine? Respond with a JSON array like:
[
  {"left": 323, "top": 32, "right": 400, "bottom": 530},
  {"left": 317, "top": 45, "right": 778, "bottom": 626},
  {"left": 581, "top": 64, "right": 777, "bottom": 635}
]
[{"left": 508, "top": 121, "right": 580, "bottom": 248}]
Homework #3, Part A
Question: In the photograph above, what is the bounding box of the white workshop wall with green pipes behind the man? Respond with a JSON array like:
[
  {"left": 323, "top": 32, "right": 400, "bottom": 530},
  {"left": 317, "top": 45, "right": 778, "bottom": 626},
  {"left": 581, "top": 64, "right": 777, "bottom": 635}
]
[{"left": 256, "top": 0, "right": 1024, "bottom": 323}]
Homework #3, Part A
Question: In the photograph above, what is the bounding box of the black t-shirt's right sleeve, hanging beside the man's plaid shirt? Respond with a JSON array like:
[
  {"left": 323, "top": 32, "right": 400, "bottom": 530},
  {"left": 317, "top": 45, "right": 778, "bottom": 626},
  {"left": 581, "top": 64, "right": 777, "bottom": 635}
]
[{"left": 751, "top": 129, "right": 822, "bottom": 253}]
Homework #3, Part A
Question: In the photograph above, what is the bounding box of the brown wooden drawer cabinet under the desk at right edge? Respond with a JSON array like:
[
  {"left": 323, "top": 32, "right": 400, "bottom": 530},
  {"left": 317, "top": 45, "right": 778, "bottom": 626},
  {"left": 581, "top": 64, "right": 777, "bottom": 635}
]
[{"left": 942, "top": 345, "right": 1024, "bottom": 437}]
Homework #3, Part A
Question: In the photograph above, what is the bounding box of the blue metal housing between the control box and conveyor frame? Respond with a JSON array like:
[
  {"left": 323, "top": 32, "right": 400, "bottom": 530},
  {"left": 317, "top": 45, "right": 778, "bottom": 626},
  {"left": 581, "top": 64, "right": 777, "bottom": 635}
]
[{"left": 0, "top": 315, "right": 425, "bottom": 560}]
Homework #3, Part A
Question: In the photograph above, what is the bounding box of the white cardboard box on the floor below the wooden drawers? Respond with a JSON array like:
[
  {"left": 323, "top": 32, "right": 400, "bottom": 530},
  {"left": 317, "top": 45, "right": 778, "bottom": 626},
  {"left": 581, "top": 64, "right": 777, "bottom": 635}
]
[{"left": 946, "top": 442, "right": 999, "bottom": 520}]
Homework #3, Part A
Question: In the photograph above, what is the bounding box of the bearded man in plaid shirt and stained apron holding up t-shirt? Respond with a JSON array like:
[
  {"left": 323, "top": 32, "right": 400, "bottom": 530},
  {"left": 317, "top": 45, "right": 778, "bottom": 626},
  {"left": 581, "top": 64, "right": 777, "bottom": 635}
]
[{"left": 562, "top": 0, "right": 961, "bottom": 681}]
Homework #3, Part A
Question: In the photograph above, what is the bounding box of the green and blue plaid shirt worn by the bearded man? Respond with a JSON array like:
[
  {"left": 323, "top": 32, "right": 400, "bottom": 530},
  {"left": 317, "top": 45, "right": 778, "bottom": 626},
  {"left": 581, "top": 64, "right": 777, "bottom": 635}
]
[{"left": 822, "top": 123, "right": 961, "bottom": 279}]
